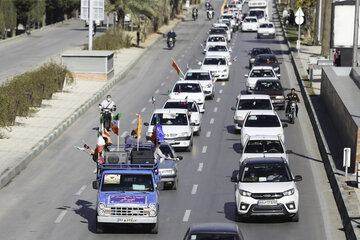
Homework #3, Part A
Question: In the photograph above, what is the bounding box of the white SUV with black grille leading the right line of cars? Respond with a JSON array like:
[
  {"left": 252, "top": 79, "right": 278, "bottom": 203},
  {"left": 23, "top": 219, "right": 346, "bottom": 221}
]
[{"left": 231, "top": 158, "right": 302, "bottom": 222}]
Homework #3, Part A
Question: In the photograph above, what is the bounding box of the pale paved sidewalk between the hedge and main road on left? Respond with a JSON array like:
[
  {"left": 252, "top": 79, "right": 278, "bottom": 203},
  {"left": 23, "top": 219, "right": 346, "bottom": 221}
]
[{"left": 0, "top": 12, "right": 187, "bottom": 189}]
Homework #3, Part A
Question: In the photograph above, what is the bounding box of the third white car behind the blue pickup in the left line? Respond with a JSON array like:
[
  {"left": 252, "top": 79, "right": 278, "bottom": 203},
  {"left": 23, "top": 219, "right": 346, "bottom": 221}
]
[{"left": 169, "top": 80, "right": 205, "bottom": 112}]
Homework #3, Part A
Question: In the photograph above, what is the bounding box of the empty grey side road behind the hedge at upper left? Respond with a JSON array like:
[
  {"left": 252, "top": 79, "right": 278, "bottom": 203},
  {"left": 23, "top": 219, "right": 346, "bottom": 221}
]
[{"left": 0, "top": 19, "right": 103, "bottom": 84}]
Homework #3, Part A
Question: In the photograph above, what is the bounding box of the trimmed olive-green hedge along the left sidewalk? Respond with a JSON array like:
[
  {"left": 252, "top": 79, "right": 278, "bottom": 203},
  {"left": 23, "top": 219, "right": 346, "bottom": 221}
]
[{"left": 0, "top": 63, "right": 74, "bottom": 127}]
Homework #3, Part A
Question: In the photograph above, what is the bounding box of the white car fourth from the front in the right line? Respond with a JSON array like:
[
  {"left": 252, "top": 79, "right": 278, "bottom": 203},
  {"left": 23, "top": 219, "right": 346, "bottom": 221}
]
[{"left": 231, "top": 94, "right": 274, "bottom": 131}]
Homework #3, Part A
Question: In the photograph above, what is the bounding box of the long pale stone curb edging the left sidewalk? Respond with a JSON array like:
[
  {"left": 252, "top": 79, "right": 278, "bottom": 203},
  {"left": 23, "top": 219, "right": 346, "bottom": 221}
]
[{"left": 0, "top": 14, "right": 186, "bottom": 189}]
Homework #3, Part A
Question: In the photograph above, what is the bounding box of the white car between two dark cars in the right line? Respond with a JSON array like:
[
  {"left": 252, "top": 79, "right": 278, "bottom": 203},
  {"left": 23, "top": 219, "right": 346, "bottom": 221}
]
[{"left": 244, "top": 66, "right": 280, "bottom": 93}]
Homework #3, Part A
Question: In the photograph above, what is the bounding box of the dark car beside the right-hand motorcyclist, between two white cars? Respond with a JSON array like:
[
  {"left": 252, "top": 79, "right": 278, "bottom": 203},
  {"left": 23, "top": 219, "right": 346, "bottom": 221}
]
[{"left": 253, "top": 78, "right": 285, "bottom": 109}]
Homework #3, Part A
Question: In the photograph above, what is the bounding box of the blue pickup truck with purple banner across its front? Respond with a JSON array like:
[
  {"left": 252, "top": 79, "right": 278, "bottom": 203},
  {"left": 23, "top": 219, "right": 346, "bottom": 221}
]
[{"left": 93, "top": 163, "right": 159, "bottom": 233}]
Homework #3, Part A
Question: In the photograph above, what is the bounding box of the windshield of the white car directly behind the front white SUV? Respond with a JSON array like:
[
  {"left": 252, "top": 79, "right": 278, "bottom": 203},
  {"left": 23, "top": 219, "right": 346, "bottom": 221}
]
[{"left": 244, "top": 140, "right": 284, "bottom": 153}]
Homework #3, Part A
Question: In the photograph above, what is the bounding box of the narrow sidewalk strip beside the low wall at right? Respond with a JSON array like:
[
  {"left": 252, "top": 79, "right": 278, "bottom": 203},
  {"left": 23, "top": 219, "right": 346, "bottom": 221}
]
[{"left": 276, "top": 4, "right": 360, "bottom": 240}]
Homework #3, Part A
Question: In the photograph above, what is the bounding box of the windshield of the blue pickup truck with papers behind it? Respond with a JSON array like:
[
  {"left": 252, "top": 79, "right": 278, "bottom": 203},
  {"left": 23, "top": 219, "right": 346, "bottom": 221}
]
[{"left": 101, "top": 173, "right": 154, "bottom": 192}]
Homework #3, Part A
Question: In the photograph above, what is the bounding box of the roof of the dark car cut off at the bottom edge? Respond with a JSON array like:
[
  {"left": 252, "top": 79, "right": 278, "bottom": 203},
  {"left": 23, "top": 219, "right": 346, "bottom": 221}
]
[{"left": 190, "top": 223, "right": 239, "bottom": 233}]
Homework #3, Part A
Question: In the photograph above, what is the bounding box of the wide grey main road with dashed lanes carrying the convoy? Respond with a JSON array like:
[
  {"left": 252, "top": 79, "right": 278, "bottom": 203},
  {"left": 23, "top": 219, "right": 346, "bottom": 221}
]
[{"left": 0, "top": 1, "right": 345, "bottom": 240}]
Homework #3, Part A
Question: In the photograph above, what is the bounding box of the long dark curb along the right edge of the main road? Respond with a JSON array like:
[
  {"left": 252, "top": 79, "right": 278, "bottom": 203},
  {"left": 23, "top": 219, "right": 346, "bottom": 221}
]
[{"left": 275, "top": 3, "right": 360, "bottom": 240}]
